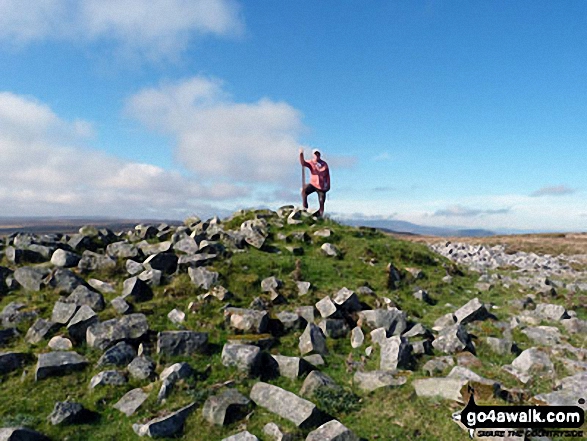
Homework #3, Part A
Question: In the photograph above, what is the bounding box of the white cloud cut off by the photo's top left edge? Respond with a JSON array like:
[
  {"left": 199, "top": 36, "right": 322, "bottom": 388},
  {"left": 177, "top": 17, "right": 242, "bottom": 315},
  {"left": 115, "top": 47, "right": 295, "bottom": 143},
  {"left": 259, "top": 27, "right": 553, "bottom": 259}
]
[{"left": 0, "top": 0, "right": 244, "bottom": 59}]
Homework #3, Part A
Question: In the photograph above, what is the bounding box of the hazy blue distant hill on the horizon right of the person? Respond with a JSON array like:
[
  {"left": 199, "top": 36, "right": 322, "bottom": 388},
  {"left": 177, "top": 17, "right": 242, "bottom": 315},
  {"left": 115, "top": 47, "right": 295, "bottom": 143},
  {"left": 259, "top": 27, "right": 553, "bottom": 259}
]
[{"left": 340, "top": 219, "right": 496, "bottom": 237}]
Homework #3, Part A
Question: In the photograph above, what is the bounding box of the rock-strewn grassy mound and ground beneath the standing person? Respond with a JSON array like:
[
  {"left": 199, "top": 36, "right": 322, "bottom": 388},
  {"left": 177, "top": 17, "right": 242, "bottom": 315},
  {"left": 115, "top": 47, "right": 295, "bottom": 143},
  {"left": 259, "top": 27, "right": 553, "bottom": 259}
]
[{"left": 0, "top": 206, "right": 587, "bottom": 441}]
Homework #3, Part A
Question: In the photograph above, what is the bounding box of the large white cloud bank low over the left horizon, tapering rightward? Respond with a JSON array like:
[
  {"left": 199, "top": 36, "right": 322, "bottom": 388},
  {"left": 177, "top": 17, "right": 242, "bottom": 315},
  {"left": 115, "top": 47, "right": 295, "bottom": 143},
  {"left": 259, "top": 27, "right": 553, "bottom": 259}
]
[{"left": 0, "top": 92, "right": 250, "bottom": 217}]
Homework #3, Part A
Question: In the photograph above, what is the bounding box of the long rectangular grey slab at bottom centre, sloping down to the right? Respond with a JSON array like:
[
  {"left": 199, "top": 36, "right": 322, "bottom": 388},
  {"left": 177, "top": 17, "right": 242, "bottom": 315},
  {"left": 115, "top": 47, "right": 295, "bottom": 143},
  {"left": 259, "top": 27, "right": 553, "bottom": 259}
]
[{"left": 250, "top": 381, "right": 322, "bottom": 428}]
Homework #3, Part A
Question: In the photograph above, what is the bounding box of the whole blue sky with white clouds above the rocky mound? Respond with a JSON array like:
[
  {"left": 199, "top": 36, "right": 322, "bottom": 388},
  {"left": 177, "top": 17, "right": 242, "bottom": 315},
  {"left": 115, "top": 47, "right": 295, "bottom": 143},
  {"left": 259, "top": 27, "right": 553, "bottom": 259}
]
[{"left": 0, "top": 0, "right": 587, "bottom": 231}]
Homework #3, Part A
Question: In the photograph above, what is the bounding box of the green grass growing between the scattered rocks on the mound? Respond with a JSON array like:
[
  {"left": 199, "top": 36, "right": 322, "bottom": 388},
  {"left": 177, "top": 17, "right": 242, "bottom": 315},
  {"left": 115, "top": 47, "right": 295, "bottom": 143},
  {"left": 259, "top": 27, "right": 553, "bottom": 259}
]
[{"left": 0, "top": 212, "right": 586, "bottom": 441}]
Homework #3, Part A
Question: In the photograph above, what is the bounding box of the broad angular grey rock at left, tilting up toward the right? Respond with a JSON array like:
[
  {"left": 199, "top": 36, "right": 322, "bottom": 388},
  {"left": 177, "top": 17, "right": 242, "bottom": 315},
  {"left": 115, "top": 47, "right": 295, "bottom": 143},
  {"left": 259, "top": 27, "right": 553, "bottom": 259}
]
[{"left": 86, "top": 314, "right": 149, "bottom": 350}]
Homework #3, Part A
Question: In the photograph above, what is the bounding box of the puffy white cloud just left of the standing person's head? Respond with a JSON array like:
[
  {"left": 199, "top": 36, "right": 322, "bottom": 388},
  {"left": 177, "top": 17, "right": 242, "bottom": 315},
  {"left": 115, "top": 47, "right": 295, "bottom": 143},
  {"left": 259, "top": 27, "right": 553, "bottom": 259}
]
[{"left": 126, "top": 77, "right": 304, "bottom": 186}]
